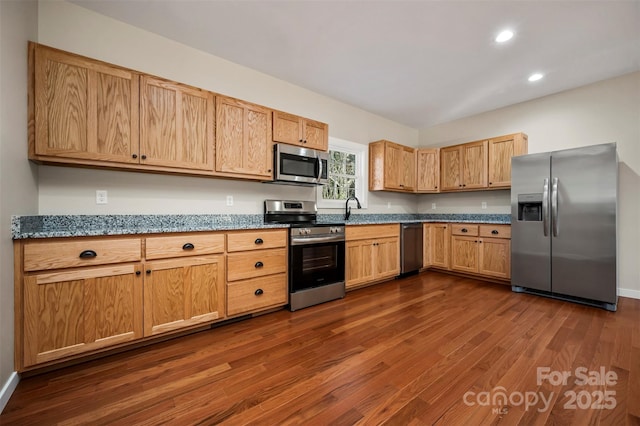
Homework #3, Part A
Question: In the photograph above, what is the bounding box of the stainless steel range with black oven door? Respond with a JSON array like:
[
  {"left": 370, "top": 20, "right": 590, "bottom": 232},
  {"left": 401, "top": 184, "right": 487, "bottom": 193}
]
[{"left": 264, "top": 200, "right": 345, "bottom": 311}]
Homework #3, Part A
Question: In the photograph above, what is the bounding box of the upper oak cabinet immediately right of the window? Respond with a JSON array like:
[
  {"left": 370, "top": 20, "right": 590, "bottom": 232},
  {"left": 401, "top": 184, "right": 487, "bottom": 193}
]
[{"left": 369, "top": 140, "right": 416, "bottom": 192}]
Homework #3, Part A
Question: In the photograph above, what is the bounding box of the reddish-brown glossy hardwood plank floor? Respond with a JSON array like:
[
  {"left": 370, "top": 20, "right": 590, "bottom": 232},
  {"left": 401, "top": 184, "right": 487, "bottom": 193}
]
[{"left": 0, "top": 272, "right": 640, "bottom": 425}]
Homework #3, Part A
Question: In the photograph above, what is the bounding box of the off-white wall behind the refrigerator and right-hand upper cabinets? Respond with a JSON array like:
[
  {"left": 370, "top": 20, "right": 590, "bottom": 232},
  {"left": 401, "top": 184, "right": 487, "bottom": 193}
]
[{"left": 418, "top": 72, "right": 640, "bottom": 298}]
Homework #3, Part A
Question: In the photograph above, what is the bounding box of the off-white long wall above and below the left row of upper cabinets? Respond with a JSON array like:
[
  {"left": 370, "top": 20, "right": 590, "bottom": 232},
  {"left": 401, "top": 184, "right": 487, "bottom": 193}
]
[{"left": 38, "top": 1, "right": 418, "bottom": 214}]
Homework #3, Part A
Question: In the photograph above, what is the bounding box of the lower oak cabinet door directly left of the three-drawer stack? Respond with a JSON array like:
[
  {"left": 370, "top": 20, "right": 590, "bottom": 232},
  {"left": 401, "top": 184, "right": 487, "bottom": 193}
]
[{"left": 144, "top": 256, "right": 225, "bottom": 336}]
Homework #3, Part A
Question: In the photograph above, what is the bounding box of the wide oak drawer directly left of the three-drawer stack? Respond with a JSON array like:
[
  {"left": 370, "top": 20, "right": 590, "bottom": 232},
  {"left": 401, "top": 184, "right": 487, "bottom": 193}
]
[{"left": 146, "top": 233, "right": 224, "bottom": 260}]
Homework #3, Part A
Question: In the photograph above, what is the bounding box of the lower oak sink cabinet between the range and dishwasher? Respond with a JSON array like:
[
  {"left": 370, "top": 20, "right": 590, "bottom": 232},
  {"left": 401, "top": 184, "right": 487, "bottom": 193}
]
[{"left": 345, "top": 224, "right": 400, "bottom": 290}]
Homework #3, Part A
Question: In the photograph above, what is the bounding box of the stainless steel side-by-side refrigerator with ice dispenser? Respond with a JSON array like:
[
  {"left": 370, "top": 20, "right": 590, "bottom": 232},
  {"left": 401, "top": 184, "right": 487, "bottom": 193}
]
[{"left": 511, "top": 143, "right": 618, "bottom": 311}]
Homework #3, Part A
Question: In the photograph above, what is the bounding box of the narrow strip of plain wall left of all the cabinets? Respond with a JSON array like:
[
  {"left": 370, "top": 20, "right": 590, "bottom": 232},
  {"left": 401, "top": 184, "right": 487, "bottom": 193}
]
[{"left": 0, "top": 1, "right": 38, "bottom": 411}]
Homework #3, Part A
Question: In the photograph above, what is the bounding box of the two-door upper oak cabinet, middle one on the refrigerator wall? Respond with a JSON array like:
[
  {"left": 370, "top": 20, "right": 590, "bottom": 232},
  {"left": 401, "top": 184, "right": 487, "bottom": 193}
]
[{"left": 440, "top": 141, "right": 489, "bottom": 191}]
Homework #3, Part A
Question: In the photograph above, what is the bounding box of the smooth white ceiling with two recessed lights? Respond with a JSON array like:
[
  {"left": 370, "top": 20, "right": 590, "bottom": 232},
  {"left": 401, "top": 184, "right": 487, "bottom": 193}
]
[{"left": 72, "top": 0, "right": 640, "bottom": 128}]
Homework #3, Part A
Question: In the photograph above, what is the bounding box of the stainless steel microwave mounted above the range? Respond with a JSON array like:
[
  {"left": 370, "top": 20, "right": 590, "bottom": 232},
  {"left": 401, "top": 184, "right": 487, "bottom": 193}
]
[{"left": 273, "top": 144, "right": 329, "bottom": 185}]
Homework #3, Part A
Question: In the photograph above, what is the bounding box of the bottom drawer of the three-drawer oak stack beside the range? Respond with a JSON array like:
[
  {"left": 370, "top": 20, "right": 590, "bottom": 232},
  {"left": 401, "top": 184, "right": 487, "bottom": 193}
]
[{"left": 227, "top": 274, "right": 288, "bottom": 315}]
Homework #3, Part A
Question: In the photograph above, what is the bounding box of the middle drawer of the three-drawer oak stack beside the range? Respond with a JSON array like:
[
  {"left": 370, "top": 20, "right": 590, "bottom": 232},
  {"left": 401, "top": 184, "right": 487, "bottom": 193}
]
[{"left": 227, "top": 249, "right": 287, "bottom": 281}]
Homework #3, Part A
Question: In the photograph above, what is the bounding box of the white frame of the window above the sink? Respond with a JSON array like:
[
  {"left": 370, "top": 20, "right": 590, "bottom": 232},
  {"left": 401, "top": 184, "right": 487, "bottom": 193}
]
[{"left": 316, "top": 136, "right": 369, "bottom": 209}]
